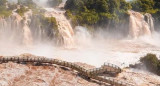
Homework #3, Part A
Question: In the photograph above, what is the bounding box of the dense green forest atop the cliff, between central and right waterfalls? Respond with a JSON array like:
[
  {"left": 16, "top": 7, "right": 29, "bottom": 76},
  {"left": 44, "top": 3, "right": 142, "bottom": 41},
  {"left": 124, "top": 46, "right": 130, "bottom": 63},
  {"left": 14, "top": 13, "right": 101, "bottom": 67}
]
[{"left": 65, "top": 0, "right": 160, "bottom": 29}]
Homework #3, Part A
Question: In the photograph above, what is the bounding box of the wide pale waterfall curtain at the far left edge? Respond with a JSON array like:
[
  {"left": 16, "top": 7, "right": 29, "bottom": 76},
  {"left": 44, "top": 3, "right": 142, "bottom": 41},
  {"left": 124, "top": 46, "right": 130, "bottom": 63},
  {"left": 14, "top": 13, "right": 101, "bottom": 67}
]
[{"left": 0, "top": 10, "right": 32, "bottom": 46}]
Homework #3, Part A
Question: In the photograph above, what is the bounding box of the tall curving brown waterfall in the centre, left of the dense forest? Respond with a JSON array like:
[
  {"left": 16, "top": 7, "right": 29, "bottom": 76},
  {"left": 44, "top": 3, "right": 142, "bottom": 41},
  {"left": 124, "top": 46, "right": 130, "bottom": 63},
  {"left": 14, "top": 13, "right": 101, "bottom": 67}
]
[{"left": 45, "top": 8, "right": 74, "bottom": 48}]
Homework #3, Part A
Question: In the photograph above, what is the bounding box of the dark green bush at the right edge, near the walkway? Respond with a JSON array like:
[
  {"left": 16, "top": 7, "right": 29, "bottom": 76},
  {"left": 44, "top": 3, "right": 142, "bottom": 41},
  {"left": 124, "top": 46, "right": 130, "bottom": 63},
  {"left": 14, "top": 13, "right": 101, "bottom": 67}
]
[{"left": 140, "top": 54, "right": 160, "bottom": 75}]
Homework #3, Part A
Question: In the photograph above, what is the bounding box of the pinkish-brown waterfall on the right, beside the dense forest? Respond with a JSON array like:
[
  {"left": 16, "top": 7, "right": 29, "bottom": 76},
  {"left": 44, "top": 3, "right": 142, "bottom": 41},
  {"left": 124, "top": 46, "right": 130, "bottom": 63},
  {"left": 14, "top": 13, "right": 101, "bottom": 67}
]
[{"left": 128, "top": 10, "right": 154, "bottom": 38}]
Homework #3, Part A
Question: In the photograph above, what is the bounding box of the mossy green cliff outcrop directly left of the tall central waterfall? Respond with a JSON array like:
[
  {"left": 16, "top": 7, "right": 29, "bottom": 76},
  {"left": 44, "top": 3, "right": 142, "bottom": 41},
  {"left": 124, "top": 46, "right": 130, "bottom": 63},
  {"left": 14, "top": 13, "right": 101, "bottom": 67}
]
[{"left": 30, "top": 14, "right": 58, "bottom": 38}]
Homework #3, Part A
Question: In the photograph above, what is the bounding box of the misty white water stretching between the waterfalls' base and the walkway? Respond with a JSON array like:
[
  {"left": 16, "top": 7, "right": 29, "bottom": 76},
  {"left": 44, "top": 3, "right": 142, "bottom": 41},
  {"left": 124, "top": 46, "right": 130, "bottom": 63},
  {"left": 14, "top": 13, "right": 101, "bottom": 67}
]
[{"left": 0, "top": 27, "right": 160, "bottom": 67}]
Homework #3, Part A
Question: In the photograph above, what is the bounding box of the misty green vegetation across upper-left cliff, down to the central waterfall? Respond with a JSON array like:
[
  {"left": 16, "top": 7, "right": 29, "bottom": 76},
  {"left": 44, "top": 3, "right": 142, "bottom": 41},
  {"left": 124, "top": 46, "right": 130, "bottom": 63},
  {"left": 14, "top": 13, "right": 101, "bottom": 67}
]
[{"left": 0, "top": 0, "right": 58, "bottom": 38}]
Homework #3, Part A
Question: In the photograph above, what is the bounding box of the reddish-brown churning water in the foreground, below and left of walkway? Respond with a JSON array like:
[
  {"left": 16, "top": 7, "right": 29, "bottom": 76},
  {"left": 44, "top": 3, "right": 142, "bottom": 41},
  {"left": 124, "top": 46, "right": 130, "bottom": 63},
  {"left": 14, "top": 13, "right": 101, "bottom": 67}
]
[{"left": 0, "top": 63, "right": 100, "bottom": 86}]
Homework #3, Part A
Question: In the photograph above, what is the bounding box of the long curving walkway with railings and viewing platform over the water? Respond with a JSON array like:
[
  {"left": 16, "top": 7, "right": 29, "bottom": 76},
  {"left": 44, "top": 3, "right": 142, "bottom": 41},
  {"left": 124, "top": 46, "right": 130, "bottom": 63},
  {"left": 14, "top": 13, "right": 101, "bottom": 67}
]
[{"left": 0, "top": 56, "right": 134, "bottom": 86}]
